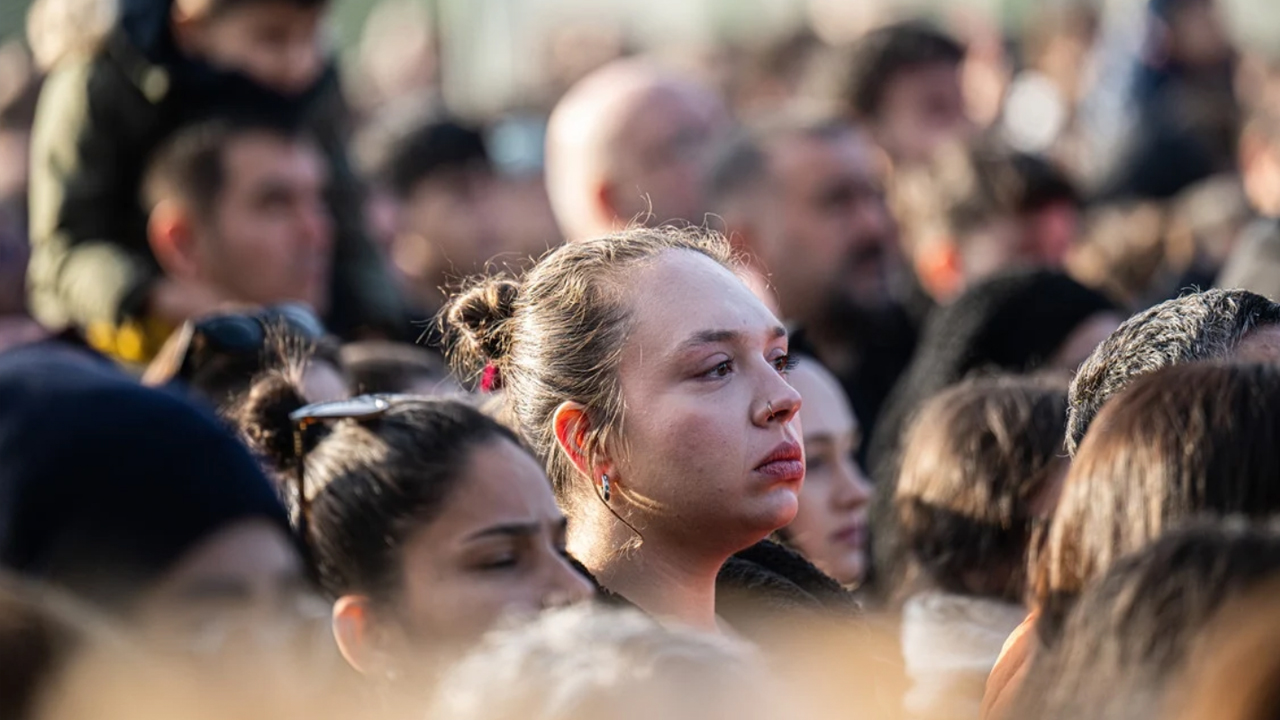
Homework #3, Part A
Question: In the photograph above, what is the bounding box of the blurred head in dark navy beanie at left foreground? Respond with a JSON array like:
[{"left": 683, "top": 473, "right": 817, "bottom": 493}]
[{"left": 0, "top": 347, "right": 307, "bottom": 651}]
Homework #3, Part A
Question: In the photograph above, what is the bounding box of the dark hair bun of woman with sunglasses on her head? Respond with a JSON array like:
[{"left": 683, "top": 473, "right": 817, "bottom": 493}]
[{"left": 234, "top": 372, "right": 319, "bottom": 473}]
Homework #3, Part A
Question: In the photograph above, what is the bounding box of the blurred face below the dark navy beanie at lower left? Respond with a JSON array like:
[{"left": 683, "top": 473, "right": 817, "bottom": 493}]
[{"left": 138, "top": 520, "right": 324, "bottom": 653}]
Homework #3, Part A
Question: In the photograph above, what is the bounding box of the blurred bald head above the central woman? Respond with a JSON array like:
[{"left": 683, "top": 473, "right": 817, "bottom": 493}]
[{"left": 547, "top": 59, "right": 724, "bottom": 240}]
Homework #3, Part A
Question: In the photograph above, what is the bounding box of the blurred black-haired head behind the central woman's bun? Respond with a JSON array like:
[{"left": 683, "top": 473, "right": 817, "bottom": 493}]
[{"left": 379, "top": 119, "right": 503, "bottom": 307}]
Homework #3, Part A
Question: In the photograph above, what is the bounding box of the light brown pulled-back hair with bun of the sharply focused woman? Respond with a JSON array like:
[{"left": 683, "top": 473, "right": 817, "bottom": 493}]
[{"left": 442, "top": 227, "right": 735, "bottom": 510}]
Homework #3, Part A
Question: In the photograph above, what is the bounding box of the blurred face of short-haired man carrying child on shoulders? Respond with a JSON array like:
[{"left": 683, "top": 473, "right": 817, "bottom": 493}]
[{"left": 197, "top": 133, "right": 333, "bottom": 313}]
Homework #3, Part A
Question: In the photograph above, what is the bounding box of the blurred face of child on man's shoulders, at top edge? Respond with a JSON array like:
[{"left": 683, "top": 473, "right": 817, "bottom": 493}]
[{"left": 170, "top": 0, "right": 329, "bottom": 95}]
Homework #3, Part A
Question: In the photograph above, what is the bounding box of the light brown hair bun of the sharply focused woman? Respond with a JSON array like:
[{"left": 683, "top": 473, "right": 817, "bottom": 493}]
[{"left": 443, "top": 277, "right": 520, "bottom": 377}]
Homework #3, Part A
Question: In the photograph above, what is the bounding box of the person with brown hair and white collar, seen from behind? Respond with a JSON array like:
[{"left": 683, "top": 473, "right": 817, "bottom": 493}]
[{"left": 893, "top": 377, "right": 1066, "bottom": 719}]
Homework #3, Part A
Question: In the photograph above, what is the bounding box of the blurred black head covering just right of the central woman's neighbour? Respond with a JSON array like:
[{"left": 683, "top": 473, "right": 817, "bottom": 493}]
[{"left": 867, "top": 270, "right": 1123, "bottom": 597}]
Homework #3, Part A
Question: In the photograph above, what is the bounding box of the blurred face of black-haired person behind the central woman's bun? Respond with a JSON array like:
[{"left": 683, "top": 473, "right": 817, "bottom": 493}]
[{"left": 393, "top": 163, "right": 503, "bottom": 297}]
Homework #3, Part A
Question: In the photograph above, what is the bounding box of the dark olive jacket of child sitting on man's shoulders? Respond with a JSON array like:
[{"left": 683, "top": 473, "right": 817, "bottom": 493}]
[{"left": 28, "top": 0, "right": 404, "bottom": 358}]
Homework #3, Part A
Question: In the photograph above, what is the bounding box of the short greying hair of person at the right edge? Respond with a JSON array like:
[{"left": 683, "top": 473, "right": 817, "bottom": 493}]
[{"left": 1066, "top": 290, "right": 1280, "bottom": 456}]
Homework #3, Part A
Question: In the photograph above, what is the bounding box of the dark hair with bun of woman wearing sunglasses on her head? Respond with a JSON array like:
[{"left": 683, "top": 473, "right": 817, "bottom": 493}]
[{"left": 237, "top": 373, "right": 518, "bottom": 601}]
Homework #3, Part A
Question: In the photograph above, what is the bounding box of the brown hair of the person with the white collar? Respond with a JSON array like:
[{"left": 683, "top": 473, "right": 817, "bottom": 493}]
[{"left": 895, "top": 377, "right": 1066, "bottom": 602}]
